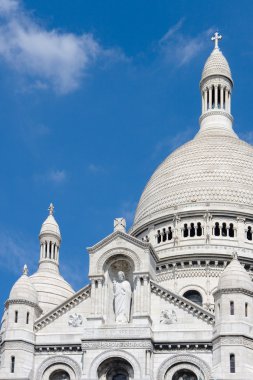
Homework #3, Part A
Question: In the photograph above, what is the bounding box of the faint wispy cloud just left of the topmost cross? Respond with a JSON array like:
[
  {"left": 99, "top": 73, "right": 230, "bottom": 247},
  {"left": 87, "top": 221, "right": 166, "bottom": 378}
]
[{"left": 158, "top": 19, "right": 214, "bottom": 67}]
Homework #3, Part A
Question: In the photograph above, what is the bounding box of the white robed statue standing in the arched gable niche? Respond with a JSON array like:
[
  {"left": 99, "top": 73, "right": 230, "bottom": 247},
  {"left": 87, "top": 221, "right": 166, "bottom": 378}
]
[{"left": 113, "top": 271, "right": 132, "bottom": 323}]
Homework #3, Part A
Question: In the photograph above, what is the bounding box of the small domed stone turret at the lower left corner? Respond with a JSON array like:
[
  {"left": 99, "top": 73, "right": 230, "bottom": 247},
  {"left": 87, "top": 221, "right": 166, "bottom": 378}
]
[{"left": 1, "top": 265, "right": 42, "bottom": 379}]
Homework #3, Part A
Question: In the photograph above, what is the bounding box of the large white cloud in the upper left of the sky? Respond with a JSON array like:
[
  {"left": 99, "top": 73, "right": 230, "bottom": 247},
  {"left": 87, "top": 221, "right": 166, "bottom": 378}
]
[{"left": 0, "top": 0, "right": 123, "bottom": 94}]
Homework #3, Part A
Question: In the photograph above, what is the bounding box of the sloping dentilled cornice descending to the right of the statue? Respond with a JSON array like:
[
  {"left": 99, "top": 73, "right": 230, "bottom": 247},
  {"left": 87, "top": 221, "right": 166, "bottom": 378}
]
[{"left": 150, "top": 280, "right": 215, "bottom": 325}]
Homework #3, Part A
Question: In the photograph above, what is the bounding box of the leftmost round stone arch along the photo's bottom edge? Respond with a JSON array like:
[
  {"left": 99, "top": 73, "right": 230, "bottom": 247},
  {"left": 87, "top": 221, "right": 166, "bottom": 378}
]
[{"left": 36, "top": 355, "right": 82, "bottom": 380}]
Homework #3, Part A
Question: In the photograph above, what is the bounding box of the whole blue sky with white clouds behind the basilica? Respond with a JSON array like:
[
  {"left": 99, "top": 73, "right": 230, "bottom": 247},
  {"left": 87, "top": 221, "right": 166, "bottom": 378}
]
[{"left": 0, "top": 0, "right": 253, "bottom": 314}]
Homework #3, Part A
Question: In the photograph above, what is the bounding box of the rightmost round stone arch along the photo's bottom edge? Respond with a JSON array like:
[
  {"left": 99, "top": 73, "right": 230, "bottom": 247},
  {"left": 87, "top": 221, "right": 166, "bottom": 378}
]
[{"left": 157, "top": 354, "right": 211, "bottom": 380}]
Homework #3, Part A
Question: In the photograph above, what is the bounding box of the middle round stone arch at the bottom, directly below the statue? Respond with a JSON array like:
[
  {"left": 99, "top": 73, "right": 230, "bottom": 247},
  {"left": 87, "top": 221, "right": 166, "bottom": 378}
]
[{"left": 88, "top": 350, "right": 142, "bottom": 380}]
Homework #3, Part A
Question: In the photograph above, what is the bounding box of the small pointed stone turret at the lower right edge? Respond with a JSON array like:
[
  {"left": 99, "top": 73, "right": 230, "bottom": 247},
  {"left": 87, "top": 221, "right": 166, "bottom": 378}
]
[{"left": 213, "top": 253, "right": 253, "bottom": 380}]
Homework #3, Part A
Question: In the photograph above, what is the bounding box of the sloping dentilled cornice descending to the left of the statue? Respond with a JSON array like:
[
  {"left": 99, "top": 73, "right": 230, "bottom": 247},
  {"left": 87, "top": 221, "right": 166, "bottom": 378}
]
[{"left": 34, "top": 284, "right": 91, "bottom": 332}]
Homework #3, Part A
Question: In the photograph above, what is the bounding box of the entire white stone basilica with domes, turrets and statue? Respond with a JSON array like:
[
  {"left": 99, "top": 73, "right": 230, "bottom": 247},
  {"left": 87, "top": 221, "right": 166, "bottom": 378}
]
[{"left": 0, "top": 33, "right": 253, "bottom": 380}]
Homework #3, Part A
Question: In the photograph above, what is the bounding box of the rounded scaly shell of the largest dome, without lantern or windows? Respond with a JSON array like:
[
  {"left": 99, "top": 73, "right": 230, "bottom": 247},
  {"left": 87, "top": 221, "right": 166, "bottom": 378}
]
[{"left": 133, "top": 128, "right": 253, "bottom": 229}]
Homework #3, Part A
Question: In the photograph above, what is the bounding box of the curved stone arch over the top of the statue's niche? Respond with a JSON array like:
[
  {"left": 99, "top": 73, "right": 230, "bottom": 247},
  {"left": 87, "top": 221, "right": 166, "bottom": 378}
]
[{"left": 97, "top": 248, "right": 140, "bottom": 273}]
